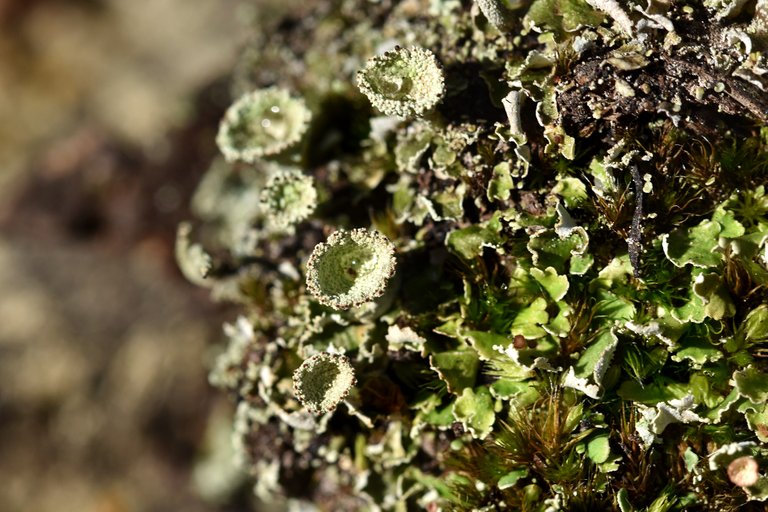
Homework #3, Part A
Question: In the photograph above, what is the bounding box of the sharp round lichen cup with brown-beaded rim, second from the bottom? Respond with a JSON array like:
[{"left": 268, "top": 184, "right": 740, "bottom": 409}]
[{"left": 307, "top": 229, "right": 395, "bottom": 309}]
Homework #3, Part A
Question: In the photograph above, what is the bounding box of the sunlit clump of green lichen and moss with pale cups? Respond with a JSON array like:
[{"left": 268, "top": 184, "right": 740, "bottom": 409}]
[{"left": 178, "top": 0, "right": 768, "bottom": 512}]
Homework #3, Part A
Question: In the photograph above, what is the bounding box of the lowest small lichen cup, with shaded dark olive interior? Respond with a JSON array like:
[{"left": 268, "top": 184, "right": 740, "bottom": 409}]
[{"left": 293, "top": 352, "right": 356, "bottom": 414}]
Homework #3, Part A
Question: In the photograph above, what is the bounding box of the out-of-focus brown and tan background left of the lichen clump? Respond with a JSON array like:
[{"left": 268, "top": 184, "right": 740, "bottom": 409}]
[{"left": 0, "top": 0, "right": 256, "bottom": 512}]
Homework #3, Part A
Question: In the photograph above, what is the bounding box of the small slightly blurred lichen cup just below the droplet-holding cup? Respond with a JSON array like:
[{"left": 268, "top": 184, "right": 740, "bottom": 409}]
[{"left": 261, "top": 169, "right": 317, "bottom": 228}]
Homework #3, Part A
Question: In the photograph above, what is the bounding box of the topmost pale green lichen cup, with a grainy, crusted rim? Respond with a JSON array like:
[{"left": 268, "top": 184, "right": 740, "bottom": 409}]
[{"left": 357, "top": 47, "right": 445, "bottom": 118}]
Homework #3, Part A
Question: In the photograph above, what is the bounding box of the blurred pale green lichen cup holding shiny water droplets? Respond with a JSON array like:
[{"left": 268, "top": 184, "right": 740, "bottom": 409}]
[{"left": 216, "top": 87, "right": 312, "bottom": 163}]
